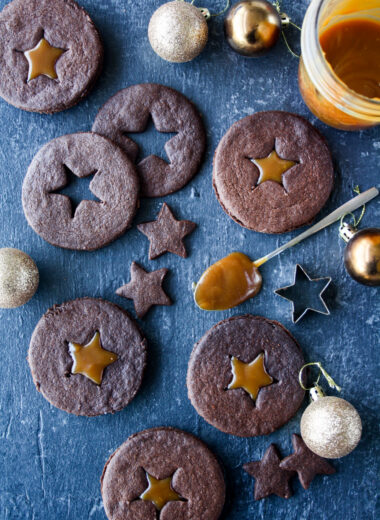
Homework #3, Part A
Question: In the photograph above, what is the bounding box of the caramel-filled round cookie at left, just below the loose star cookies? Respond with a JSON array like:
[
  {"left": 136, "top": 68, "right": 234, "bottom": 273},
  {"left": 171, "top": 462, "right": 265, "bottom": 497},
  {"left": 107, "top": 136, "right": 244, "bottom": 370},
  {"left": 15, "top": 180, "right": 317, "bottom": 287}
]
[{"left": 28, "top": 298, "right": 146, "bottom": 416}]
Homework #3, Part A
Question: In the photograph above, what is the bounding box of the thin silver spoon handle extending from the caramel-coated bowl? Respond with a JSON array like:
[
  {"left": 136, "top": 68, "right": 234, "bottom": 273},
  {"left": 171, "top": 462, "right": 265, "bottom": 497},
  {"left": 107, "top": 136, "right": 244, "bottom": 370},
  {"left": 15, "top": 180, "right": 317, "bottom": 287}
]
[{"left": 253, "top": 188, "right": 379, "bottom": 267}]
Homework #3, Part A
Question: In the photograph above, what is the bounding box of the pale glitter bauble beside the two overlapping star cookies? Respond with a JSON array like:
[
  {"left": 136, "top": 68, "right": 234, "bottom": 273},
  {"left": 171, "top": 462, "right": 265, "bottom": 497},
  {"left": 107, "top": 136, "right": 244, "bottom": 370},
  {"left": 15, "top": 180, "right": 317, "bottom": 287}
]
[{"left": 301, "top": 396, "right": 362, "bottom": 459}]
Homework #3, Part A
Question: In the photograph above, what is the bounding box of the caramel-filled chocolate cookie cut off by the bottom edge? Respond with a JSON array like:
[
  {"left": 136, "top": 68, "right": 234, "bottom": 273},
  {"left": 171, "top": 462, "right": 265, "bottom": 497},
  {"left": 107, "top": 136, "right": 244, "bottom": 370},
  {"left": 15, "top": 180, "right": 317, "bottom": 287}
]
[{"left": 101, "top": 428, "right": 225, "bottom": 520}]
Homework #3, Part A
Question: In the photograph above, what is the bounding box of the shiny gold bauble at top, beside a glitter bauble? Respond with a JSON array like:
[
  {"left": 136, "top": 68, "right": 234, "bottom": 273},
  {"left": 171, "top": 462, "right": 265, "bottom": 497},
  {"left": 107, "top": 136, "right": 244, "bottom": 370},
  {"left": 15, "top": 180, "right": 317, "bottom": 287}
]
[{"left": 224, "top": 0, "right": 282, "bottom": 57}]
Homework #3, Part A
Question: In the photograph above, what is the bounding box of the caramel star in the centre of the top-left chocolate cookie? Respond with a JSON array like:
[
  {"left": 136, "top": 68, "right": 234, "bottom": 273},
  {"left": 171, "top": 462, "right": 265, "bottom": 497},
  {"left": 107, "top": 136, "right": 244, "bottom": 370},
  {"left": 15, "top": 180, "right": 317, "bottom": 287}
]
[{"left": 24, "top": 38, "right": 66, "bottom": 82}]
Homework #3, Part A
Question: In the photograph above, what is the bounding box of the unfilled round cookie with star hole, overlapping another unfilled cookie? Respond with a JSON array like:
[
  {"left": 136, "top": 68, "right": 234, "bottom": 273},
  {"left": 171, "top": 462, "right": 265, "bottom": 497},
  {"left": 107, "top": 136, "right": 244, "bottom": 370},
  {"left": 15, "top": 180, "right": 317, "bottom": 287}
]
[{"left": 22, "top": 132, "right": 139, "bottom": 251}]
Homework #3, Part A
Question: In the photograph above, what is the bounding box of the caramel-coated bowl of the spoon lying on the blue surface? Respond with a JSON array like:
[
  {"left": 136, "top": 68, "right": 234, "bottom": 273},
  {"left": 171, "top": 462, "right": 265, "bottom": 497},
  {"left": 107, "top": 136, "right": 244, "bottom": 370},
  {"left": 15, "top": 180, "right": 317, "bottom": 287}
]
[{"left": 194, "top": 253, "right": 262, "bottom": 311}]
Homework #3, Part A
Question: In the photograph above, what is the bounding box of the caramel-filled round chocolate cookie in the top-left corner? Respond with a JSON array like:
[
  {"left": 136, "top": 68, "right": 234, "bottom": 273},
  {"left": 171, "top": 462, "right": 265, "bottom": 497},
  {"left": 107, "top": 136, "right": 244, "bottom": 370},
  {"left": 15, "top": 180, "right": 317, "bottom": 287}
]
[{"left": 0, "top": 0, "right": 103, "bottom": 114}]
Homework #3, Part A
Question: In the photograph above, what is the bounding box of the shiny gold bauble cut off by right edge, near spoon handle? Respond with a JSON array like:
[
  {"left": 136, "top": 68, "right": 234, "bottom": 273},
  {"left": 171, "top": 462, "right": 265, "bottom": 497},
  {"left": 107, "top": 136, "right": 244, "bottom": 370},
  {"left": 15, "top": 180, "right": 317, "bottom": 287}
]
[{"left": 344, "top": 228, "right": 380, "bottom": 286}]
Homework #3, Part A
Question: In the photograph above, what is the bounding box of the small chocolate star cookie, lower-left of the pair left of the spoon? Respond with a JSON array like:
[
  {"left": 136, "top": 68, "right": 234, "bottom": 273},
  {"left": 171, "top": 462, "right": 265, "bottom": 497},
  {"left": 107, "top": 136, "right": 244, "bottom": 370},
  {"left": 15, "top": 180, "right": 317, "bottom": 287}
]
[{"left": 116, "top": 262, "right": 172, "bottom": 318}]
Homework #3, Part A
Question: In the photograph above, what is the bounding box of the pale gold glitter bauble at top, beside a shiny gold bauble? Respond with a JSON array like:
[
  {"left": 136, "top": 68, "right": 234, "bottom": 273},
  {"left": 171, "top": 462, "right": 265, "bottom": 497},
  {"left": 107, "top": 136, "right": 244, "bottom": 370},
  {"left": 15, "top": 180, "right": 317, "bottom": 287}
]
[{"left": 148, "top": 0, "right": 208, "bottom": 63}]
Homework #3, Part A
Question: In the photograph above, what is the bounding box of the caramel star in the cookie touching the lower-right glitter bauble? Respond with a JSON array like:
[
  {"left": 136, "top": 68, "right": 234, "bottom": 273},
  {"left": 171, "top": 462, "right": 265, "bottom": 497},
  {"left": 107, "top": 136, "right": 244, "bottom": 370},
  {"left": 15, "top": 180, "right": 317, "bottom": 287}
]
[{"left": 228, "top": 352, "right": 273, "bottom": 401}]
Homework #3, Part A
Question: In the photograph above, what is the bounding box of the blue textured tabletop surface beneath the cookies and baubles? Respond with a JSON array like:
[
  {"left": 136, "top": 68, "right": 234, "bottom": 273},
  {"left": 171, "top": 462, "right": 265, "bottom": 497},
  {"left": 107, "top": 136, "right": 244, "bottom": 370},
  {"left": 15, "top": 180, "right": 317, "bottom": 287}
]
[{"left": 0, "top": 0, "right": 380, "bottom": 520}]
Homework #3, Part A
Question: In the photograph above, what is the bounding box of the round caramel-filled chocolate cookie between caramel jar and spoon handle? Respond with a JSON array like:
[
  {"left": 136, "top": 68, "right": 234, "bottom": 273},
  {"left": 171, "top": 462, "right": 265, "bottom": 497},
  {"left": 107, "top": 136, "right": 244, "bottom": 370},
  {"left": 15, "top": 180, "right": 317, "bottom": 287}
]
[{"left": 213, "top": 112, "right": 334, "bottom": 233}]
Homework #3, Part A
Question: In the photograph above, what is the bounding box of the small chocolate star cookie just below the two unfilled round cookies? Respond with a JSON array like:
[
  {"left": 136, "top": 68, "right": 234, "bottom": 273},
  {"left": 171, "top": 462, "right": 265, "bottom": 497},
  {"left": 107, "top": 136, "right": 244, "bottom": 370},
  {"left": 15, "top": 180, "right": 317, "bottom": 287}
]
[{"left": 137, "top": 202, "right": 197, "bottom": 260}]
